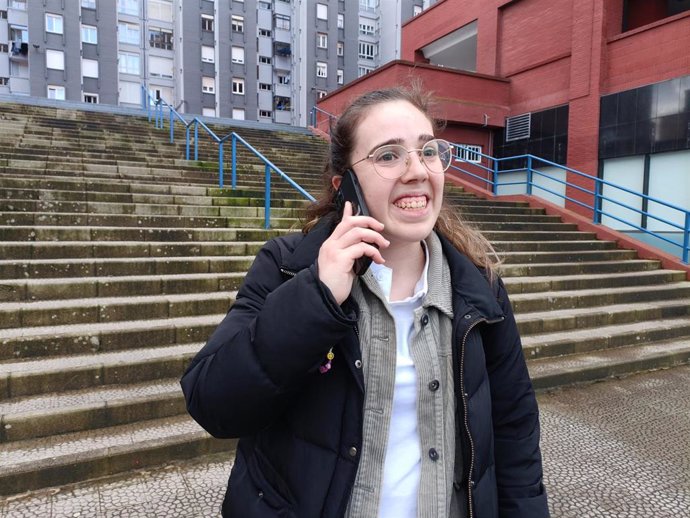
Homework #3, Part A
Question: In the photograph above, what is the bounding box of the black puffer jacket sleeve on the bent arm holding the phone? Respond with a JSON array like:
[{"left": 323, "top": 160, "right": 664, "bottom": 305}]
[{"left": 181, "top": 238, "right": 355, "bottom": 437}]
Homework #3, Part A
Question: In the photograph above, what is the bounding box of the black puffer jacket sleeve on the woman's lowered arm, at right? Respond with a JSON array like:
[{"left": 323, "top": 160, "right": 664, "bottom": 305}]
[{"left": 483, "top": 279, "right": 549, "bottom": 518}]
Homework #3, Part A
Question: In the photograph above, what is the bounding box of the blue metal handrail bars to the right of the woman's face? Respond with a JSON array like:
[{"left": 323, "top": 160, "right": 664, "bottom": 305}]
[{"left": 451, "top": 144, "right": 690, "bottom": 264}]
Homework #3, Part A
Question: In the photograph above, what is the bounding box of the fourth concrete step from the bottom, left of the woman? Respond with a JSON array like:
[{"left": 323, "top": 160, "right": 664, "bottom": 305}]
[{"left": 0, "top": 313, "right": 225, "bottom": 364}]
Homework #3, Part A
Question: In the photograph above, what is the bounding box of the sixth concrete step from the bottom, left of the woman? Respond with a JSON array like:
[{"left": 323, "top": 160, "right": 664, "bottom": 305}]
[{"left": 0, "top": 270, "right": 245, "bottom": 303}]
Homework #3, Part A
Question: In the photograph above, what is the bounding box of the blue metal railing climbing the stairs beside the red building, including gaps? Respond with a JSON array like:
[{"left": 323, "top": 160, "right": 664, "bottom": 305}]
[{"left": 451, "top": 144, "right": 690, "bottom": 264}]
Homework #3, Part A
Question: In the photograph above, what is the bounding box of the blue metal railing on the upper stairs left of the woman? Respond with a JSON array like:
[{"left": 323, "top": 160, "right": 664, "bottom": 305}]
[{"left": 141, "top": 86, "right": 315, "bottom": 228}]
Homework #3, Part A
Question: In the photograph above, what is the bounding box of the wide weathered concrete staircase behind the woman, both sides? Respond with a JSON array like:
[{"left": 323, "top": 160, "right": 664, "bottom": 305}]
[{"left": 0, "top": 105, "right": 690, "bottom": 495}]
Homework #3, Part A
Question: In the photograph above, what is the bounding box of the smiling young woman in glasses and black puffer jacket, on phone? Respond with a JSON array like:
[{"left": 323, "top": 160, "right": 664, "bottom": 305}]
[{"left": 182, "top": 89, "right": 548, "bottom": 518}]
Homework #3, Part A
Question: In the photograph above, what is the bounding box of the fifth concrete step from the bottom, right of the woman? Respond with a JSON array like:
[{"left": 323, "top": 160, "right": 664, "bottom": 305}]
[{"left": 504, "top": 270, "right": 685, "bottom": 296}]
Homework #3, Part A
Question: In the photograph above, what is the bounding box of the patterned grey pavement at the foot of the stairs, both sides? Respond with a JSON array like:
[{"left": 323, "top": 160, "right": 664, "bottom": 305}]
[{"left": 0, "top": 366, "right": 690, "bottom": 518}]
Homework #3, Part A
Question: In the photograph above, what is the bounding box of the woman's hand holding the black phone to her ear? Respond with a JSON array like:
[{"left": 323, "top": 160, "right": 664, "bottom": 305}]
[{"left": 317, "top": 201, "right": 390, "bottom": 304}]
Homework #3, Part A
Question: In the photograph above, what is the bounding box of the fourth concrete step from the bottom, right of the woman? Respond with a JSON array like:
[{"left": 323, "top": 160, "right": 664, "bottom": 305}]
[{"left": 511, "top": 282, "right": 690, "bottom": 314}]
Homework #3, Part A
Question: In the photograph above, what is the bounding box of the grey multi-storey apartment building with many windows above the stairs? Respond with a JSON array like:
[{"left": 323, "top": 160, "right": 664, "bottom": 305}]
[{"left": 0, "top": 0, "right": 422, "bottom": 126}]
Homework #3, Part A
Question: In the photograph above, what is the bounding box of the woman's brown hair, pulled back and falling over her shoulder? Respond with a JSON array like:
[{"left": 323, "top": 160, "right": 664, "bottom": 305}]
[{"left": 302, "top": 84, "right": 499, "bottom": 274}]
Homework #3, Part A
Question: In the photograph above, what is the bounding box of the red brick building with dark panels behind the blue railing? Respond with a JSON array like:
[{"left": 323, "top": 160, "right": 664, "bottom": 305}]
[{"left": 318, "top": 0, "right": 690, "bottom": 236}]
